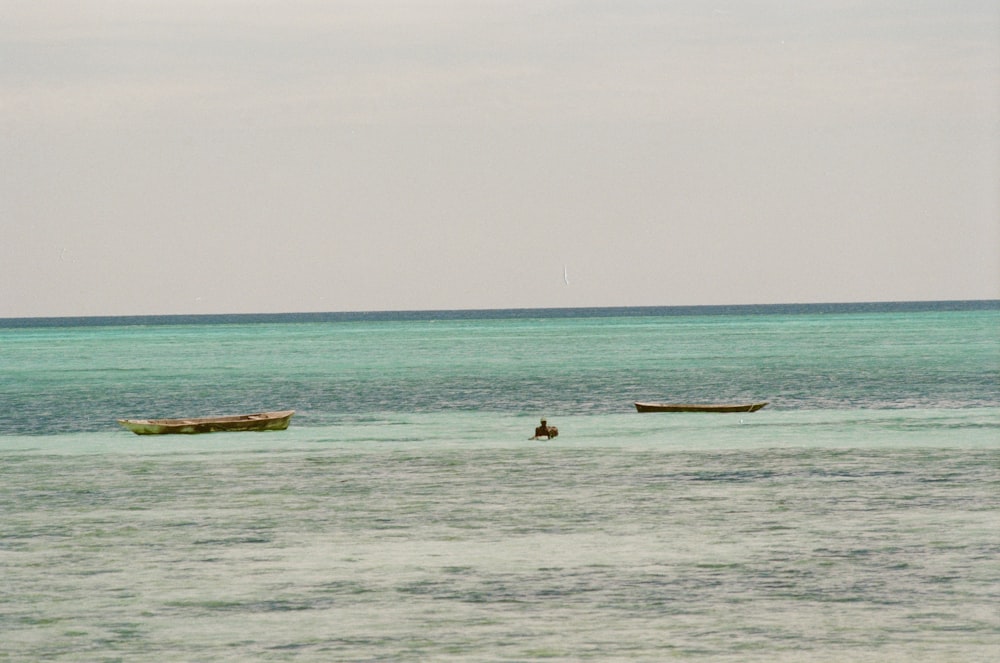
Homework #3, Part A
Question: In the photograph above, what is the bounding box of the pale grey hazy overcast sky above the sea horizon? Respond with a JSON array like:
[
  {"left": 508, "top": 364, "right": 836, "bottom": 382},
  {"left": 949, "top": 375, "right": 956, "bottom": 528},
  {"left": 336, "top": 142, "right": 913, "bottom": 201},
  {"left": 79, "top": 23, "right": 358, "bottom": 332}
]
[{"left": 0, "top": 0, "right": 1000, "bottom": 317}]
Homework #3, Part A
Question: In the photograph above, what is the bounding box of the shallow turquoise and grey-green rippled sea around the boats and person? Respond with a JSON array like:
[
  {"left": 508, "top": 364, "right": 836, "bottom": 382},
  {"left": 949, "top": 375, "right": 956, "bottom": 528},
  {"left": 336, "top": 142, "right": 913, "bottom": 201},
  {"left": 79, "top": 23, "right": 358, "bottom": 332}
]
[{"left": 0, "top": 301, "right": 1000, "bottom": 663}]
